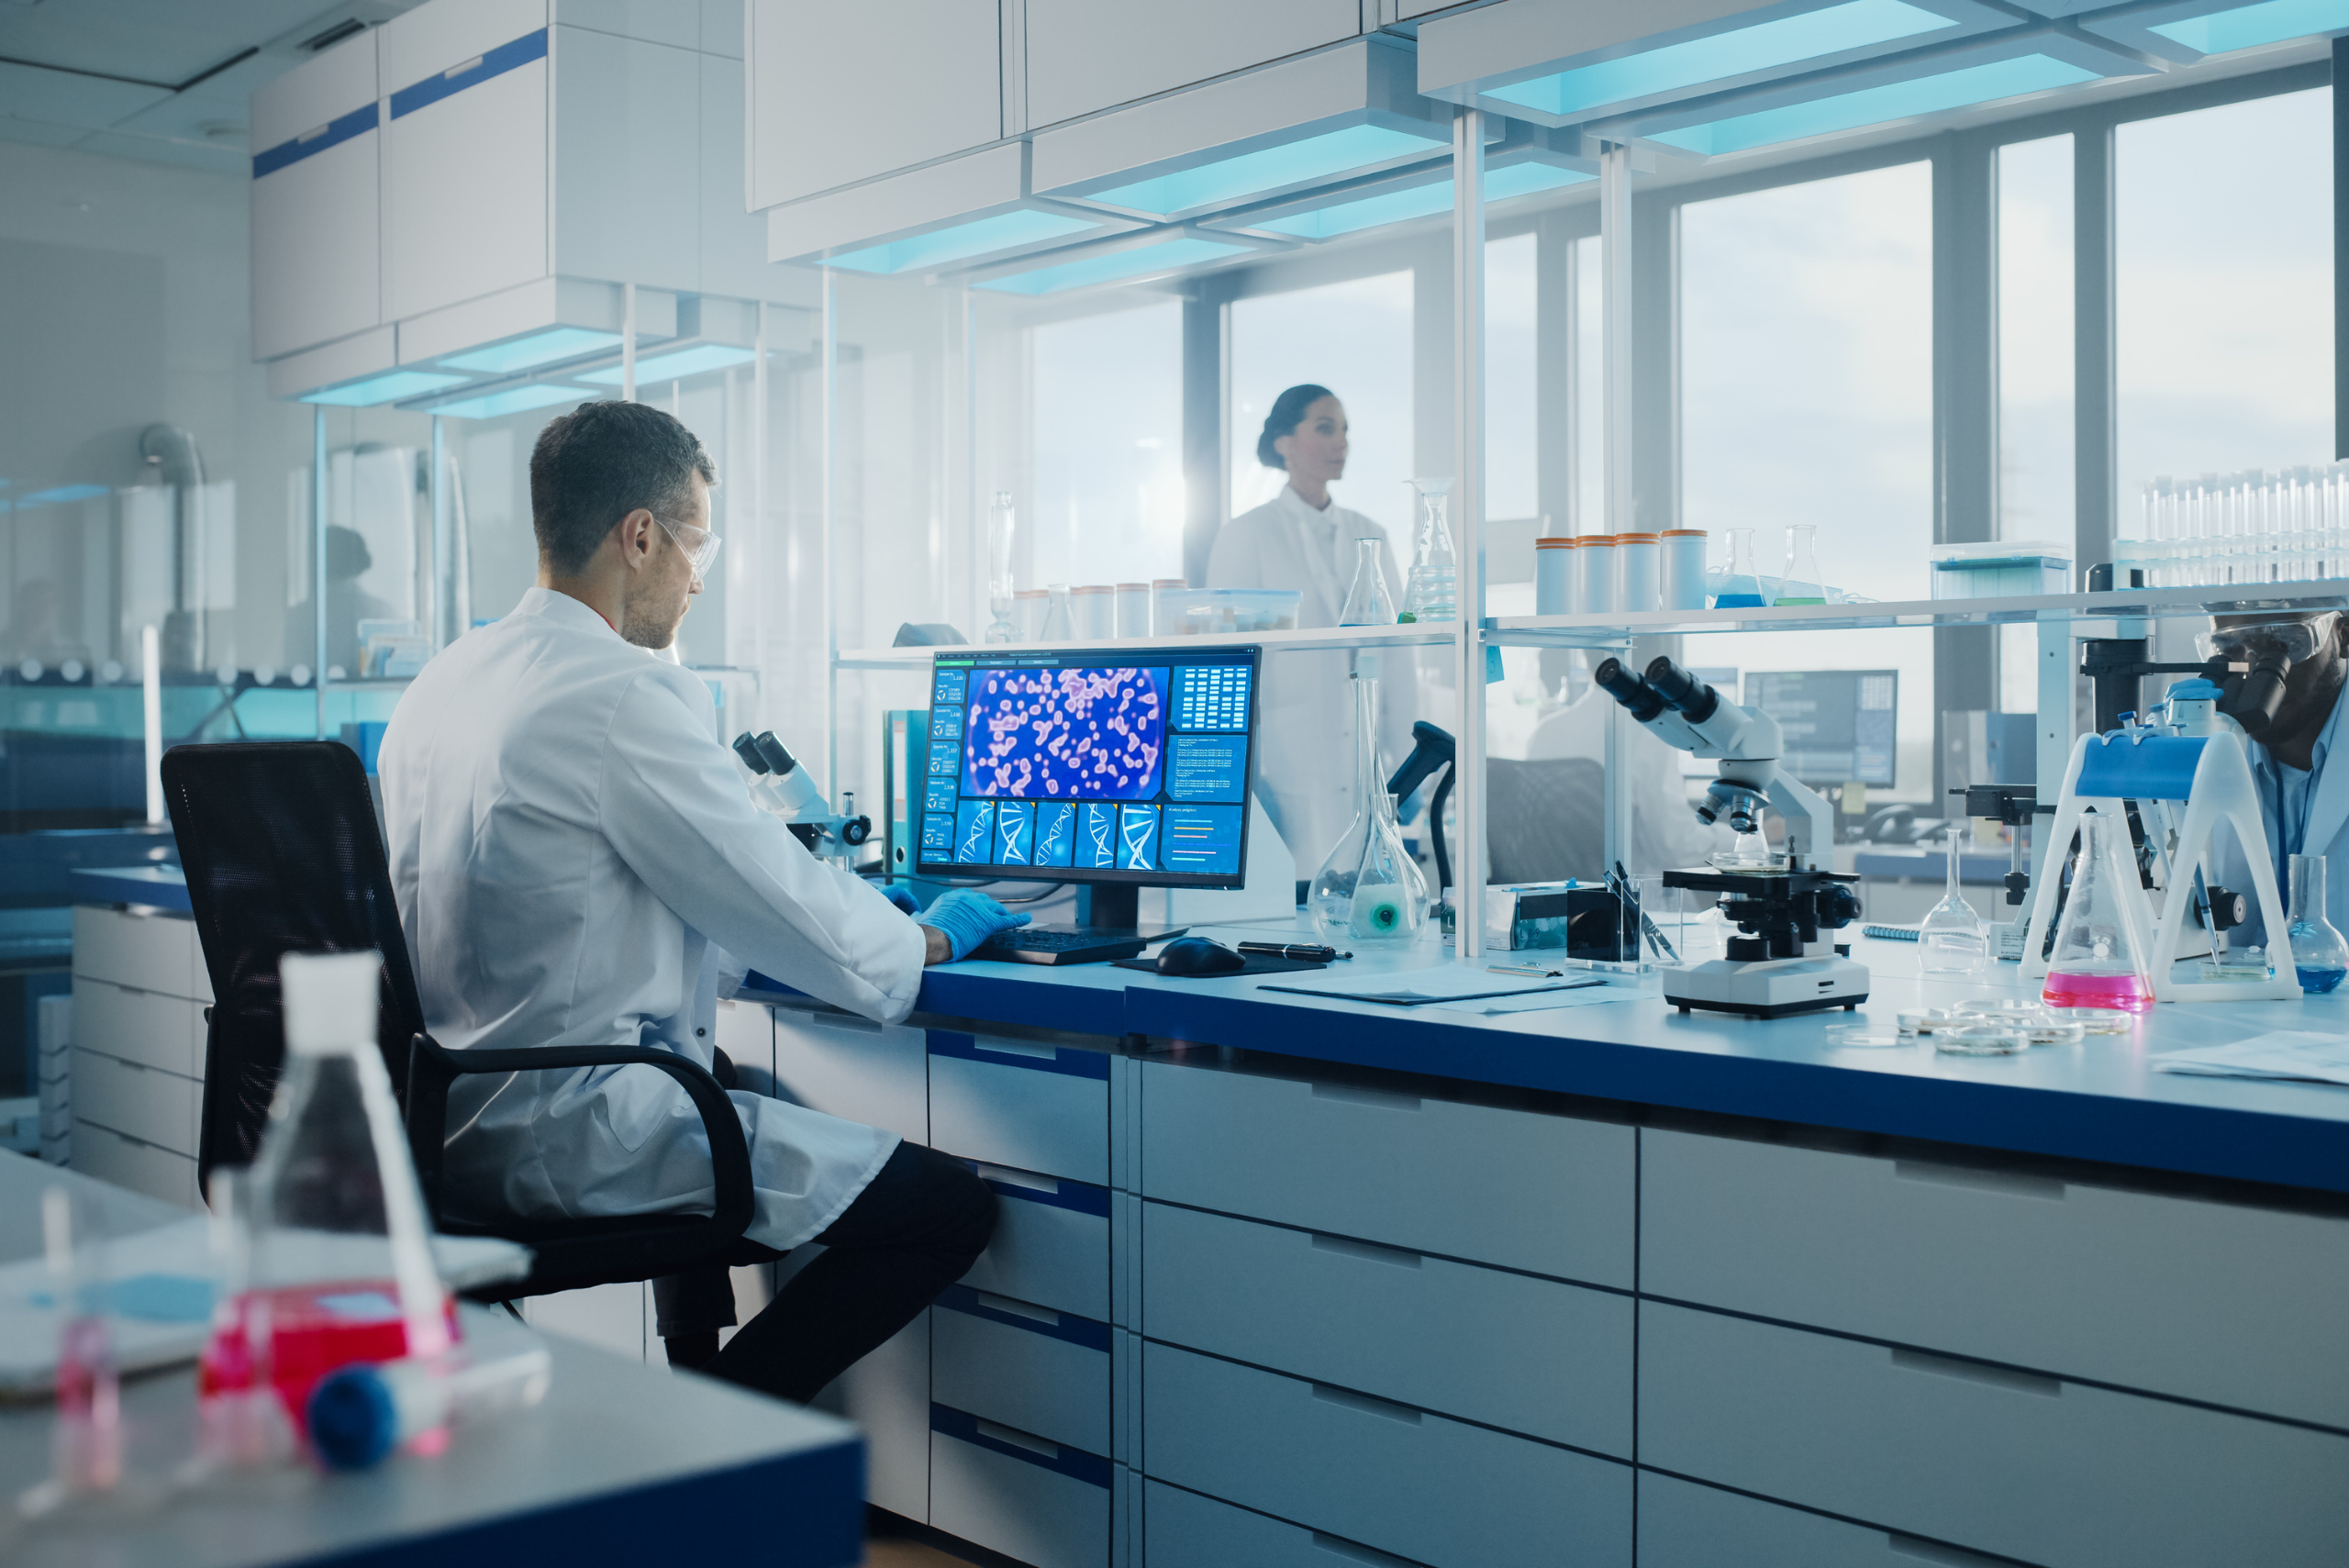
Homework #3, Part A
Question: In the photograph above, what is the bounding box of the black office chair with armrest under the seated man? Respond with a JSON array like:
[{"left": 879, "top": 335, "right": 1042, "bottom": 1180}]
[{"left": 162, "top": 741, "right": 782, "bottom": 1300}]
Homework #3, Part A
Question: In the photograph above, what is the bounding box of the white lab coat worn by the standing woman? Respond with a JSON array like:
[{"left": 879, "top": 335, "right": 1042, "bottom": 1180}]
[{"left": 1208, "top": 486, "right": 1423, "bottom": 878}]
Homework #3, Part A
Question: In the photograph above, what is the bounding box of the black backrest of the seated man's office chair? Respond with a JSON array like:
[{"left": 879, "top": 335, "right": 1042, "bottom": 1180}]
[{"left": 162, "top": 740, "right": 425, "bottom": 1181}]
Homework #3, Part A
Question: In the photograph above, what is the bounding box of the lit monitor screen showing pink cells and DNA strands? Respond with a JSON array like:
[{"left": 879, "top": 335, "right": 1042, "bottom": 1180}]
[{"left": 921, "top": 646, "right": 1259, "bottom": 887}]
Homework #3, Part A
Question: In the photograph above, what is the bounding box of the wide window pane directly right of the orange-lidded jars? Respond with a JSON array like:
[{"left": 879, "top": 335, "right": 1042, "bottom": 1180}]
[{"left": 1679, "top": 162, "right": 1933, "bottom": 794}]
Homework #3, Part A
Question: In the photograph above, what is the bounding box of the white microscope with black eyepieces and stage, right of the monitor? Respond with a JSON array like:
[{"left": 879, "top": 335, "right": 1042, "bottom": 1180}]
[{"left": 1590, "top": 660, "right": 1867, "bottom": 1018}]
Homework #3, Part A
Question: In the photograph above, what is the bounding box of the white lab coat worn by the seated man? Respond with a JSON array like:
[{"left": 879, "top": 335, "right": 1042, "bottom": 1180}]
[{"left": 378, "top": 587, "right": 923, "bottom": 1249}]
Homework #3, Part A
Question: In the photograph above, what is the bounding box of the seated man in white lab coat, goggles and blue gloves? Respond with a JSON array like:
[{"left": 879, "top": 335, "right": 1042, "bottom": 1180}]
[{"left": 381, "top": 401, "right": 1017, "bottom": 1401}]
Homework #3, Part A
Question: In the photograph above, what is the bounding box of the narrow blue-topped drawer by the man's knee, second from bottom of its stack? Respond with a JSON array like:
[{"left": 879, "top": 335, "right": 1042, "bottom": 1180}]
[{"left": 930, "top": 1284, "right": 1108, "bottom": 1455}]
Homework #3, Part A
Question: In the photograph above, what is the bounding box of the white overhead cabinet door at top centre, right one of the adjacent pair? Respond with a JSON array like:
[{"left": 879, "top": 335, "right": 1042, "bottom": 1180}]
[{"left": 1027, "top": 0, "right": 1363, "bottom": 129}]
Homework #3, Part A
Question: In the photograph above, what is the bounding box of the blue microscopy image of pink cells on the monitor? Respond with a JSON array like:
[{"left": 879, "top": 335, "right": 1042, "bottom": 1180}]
[{"left": 963, "top": 669, "right": 1167, "bottom": 800}]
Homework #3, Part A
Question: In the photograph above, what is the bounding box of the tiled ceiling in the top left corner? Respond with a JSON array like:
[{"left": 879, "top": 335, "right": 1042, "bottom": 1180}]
[{"left": 0, "top": 0, "right": 418, "bottom": 173}]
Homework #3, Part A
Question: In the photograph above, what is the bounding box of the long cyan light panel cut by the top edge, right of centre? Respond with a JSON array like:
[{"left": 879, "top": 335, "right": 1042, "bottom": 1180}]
[{"left": 1485, "top": 0, "right": 1956, "bottom": 117}]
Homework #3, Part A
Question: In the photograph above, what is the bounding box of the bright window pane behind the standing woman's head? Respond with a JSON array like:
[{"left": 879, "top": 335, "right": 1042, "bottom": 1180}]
[{"left": 1230, "top": 272, "right": 1419, "bottom": 551}]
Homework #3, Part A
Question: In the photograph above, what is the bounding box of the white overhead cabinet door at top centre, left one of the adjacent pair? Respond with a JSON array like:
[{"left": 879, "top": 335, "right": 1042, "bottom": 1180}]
[{"left": 750, "top": 0, "right": 1003, "bottom": 209}]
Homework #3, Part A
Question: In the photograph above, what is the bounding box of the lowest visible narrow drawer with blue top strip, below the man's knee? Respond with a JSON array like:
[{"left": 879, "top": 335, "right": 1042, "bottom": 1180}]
[{"left": 930, "top": 1404, "right": 1113, "bottom": 1568}]
